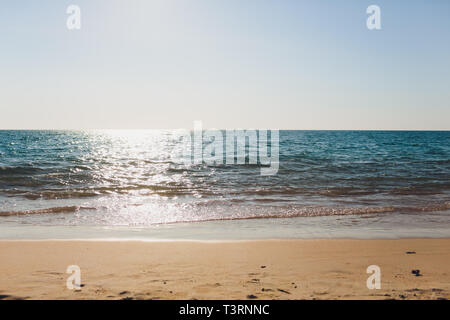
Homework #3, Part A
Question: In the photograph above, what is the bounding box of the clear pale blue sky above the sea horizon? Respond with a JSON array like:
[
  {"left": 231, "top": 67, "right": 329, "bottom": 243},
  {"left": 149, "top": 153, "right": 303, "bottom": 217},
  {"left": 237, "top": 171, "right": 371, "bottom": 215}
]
[{"left": 0, "top": 0, "right": 450, "bottom": 130}]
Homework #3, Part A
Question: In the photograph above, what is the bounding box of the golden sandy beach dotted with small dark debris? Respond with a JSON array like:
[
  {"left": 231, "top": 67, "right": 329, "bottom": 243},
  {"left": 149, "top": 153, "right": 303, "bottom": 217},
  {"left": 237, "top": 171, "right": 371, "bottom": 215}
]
[{"left": 0, "top": 239, "right": 450, "bottom": 299}]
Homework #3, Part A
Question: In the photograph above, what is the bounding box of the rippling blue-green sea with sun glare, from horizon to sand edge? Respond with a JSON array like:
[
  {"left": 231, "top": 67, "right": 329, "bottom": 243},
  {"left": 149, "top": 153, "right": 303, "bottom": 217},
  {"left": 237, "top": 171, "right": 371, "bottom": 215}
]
[{"left": 0, "top": 130, "right": 450, "bottom": 239}]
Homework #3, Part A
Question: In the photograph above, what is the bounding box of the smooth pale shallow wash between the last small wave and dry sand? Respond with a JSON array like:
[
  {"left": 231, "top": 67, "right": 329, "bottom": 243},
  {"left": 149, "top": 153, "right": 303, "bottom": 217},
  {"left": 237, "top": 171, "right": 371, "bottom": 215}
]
[{"left": 0, "top": 211, "right": 450, "bottom": 242}]
